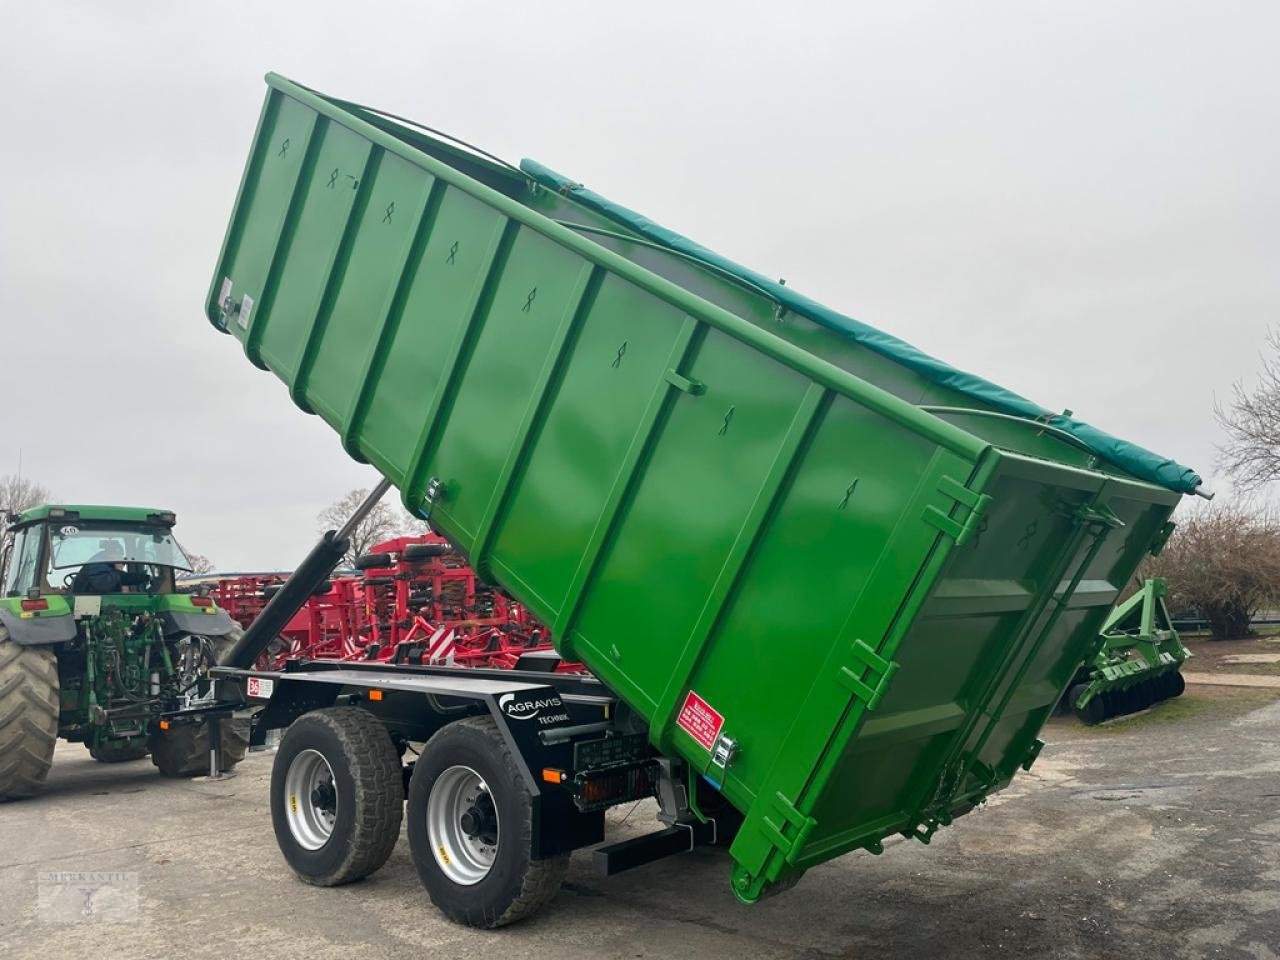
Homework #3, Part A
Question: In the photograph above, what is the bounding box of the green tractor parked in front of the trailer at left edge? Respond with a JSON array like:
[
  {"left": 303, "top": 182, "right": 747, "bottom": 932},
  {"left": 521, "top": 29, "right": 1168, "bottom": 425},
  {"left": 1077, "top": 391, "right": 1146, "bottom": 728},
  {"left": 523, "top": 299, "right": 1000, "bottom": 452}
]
[{"left": 0, "top": 504, "right": 248, "bottom": 800}]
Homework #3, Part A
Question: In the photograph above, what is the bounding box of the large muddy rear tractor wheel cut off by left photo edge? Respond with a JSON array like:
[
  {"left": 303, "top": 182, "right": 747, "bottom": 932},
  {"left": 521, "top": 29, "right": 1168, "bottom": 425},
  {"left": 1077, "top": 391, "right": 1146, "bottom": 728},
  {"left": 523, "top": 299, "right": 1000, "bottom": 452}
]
[{"left": 0, "top": 627, "right": 58, "bottom": 800}]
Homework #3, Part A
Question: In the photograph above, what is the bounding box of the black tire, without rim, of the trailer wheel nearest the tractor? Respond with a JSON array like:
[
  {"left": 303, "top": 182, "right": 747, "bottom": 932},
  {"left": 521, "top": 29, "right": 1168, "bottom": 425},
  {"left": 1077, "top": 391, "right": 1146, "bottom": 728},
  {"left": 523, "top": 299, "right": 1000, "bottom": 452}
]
[{"left": 271, "top": 707, "right": 404, "bottom": 887}]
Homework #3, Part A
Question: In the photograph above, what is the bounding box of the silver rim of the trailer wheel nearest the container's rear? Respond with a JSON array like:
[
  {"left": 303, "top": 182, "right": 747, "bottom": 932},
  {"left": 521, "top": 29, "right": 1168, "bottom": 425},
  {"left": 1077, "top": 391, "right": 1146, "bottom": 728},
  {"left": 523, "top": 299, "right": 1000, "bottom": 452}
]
[{"left": 426, "top": 765, "right": 500, "bottom": 887}]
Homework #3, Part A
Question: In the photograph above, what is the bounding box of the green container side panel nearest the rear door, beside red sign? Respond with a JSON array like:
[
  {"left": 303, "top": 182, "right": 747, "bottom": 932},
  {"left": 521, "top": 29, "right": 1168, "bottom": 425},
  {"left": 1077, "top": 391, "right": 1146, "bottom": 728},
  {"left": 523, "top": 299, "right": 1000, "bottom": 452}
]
[{"left": 691, "top": 397, "right": 936, "bottom": 794}]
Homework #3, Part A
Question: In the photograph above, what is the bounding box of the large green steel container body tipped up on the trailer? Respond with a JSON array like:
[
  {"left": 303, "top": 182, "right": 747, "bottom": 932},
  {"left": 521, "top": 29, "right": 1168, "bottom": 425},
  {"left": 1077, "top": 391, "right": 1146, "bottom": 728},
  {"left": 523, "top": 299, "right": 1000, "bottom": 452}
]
[{"left": 206, "top": 76, "right": 1179, "bottom": 900}]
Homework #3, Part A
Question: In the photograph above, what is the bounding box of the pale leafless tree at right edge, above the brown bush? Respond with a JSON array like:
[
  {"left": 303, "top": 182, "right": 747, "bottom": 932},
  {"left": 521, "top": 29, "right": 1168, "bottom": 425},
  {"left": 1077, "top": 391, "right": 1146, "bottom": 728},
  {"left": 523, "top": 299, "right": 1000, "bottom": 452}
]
[{"left": 1213, "top": 329, "right": 1280, "bottom": 490}]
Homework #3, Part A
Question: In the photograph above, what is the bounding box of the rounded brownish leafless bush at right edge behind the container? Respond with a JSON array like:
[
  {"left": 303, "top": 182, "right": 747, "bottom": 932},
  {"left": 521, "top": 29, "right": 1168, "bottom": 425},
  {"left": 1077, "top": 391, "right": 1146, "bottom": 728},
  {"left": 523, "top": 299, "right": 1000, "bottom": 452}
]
[{"left": 1143, "top": 503, "right": 1280, "bottom": 640}]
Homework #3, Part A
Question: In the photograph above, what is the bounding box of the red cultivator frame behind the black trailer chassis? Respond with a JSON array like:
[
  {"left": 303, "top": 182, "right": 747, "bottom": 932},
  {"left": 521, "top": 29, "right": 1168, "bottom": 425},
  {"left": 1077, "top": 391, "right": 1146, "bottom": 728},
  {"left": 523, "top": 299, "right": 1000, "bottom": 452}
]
[{"left": 207, "top": 534, "right": 581, "bottom": 672}]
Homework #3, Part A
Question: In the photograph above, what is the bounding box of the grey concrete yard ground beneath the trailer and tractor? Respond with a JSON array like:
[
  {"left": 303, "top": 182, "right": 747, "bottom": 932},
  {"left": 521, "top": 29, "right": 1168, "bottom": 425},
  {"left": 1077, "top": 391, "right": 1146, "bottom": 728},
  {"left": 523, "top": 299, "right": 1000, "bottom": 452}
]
[{"left": 0, "top": 686, "right": 1280, "bottom": 960}]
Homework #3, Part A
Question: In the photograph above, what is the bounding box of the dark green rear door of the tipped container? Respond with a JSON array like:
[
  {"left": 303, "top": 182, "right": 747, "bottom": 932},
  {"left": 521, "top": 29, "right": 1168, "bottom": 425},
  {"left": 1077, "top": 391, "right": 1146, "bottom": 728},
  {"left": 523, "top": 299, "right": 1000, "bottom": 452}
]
[{"left": 747, "top": 453, "right": 1179, "bottom": 880}]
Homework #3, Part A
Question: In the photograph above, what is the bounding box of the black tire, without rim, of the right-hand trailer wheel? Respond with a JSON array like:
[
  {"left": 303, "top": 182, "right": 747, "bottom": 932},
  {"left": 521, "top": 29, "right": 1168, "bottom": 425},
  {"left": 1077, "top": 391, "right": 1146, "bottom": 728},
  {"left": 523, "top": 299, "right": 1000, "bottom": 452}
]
[{"left": 407, "top": 717, "right": 570, "bottom": 929}]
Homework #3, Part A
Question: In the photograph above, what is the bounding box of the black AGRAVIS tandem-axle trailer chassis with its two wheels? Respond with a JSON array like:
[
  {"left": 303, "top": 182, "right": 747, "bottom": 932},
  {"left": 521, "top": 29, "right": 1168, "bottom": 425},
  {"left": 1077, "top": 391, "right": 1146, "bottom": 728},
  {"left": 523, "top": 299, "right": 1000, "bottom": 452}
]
[{"left": 215, "top": 657, "right": 741, "bottom": 927}]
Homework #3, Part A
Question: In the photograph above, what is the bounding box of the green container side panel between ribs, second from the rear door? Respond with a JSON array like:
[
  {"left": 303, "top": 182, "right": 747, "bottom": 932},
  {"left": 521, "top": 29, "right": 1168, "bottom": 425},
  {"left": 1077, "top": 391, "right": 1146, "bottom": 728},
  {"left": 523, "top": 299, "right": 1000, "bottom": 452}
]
[{"left": 570, "top": 332, "right": 809, "bottom": 716}]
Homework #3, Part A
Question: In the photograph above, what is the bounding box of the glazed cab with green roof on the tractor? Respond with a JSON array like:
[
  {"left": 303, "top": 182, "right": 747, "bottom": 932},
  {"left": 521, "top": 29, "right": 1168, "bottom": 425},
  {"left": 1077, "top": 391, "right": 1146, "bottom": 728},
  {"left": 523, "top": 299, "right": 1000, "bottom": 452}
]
[{"left": 0, "top": 504, "right": 191, "bottom": 598}]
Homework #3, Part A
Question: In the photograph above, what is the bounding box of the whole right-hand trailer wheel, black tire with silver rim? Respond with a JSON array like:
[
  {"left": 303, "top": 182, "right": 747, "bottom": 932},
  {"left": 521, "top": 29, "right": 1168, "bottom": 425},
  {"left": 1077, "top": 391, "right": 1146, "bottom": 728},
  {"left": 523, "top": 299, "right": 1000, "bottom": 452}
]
[{"left": 407, "top": 717, "right": 570, "bottom": 929}]
